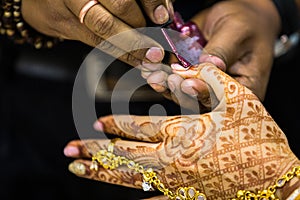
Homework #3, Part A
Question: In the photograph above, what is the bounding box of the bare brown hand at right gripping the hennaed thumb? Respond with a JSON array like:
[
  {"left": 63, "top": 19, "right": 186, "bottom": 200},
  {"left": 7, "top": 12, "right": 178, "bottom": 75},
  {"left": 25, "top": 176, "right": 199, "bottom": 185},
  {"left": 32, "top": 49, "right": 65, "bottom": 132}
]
[{"left": 144, "top": 0, "right": 280, "bottom": 109}]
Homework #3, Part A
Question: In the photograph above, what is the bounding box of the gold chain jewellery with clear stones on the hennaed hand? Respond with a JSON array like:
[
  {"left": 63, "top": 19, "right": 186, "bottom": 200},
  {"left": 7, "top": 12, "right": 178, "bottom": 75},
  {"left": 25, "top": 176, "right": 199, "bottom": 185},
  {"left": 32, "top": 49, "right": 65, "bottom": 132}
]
[{"left": 90, "top": 139, "right": 300, "bottom": 200}]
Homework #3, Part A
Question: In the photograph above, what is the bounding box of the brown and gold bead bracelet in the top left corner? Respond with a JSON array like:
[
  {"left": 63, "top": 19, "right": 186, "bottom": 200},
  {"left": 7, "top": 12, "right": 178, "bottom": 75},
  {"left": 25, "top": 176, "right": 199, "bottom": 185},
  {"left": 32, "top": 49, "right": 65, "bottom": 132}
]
[{"left": 0, "top": 0, "right": 62, "bottom": 49}]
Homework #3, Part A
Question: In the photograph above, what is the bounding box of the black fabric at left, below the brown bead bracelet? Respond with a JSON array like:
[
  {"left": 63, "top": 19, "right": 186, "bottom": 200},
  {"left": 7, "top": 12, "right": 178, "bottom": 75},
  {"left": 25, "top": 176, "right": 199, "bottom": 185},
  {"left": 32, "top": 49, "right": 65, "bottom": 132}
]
[{"left": 0, "top": 40, "right": 178, "bottom": 200}]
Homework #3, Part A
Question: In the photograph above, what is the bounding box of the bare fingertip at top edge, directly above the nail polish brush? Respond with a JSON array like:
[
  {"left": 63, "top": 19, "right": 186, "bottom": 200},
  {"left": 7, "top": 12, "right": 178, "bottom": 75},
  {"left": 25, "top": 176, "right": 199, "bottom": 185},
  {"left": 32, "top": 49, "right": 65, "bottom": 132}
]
[{"left": 141, "top": 0, "right": 169, "bottom": 24}]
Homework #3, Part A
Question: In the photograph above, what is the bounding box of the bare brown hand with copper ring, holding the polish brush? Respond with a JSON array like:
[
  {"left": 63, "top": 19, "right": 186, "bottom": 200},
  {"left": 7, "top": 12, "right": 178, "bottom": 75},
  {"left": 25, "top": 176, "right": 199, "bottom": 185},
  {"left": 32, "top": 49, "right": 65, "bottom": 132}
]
[{"left": 22, "top": 0, "right": 169, "bottom": 66}]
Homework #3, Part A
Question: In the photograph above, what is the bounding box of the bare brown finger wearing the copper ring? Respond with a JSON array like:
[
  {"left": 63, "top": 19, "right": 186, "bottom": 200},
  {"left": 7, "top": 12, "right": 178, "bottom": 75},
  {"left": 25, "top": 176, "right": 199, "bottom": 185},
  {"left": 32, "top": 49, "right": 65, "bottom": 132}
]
[{"left": 67, "top": 1, "right": 164, "bottom": 62}]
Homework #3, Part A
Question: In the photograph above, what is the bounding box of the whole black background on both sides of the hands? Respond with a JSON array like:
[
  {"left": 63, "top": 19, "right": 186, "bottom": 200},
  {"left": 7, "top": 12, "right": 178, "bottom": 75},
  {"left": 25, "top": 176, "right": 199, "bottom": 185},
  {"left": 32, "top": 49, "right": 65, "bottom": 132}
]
[{"left": 0, "top": 0, "right": 300, "bottom": 200}]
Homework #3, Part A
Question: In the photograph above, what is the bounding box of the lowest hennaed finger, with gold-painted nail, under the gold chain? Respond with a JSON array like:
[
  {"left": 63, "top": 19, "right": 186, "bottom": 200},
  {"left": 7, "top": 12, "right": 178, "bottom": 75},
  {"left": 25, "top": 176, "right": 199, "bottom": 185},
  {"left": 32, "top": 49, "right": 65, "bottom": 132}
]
[{"left": 68, "top": 159, "right": 142, "bottom": 189}]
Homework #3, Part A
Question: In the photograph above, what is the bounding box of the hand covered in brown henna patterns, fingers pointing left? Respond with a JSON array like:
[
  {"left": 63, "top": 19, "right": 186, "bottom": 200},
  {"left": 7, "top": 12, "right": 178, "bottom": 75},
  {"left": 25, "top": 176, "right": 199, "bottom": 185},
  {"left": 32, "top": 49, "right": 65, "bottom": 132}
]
[{"left": 65, "top": 63, "right": 300, "bottom": 199}]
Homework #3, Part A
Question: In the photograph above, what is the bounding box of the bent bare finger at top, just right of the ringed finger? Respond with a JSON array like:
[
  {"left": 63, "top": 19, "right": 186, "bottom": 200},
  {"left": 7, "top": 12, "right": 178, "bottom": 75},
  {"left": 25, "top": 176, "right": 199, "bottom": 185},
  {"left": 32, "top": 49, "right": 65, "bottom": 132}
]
[{"left": 99, "top": 0, "right": 146, "bottom": 28}]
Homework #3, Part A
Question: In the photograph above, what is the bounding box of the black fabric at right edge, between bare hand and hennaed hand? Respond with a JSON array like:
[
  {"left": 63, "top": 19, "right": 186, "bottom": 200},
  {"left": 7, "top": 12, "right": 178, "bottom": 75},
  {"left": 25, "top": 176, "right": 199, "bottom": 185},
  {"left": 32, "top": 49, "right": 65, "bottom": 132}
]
[{"left": 263, "top": 41, "right": 300, "bottom": 158}]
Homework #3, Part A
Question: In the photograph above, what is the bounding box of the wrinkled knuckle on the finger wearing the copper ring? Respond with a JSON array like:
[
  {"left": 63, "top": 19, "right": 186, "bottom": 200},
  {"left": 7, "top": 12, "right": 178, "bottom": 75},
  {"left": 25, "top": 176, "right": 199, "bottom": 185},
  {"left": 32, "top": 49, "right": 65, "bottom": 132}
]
[{"left": 92, "top": 13, "right": 114, "bottom": 37}]
